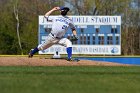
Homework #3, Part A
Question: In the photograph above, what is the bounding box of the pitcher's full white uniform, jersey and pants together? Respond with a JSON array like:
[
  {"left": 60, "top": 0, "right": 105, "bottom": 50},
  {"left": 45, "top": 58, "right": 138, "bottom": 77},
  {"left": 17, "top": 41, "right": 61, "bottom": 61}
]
[{"left": 38, "top": 16, "right": 75, "bottom": 50}]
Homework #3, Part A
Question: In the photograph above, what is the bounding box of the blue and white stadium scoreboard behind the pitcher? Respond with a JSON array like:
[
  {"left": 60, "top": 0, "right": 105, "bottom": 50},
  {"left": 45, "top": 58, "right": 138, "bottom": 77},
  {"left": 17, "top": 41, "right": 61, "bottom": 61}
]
[{"left": 38, "top": 16, "right": 121, "bottom": 55}]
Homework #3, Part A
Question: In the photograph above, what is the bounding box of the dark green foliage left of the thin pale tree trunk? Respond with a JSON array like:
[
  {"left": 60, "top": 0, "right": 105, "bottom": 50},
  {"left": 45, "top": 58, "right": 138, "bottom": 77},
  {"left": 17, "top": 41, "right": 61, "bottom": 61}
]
[{"left": 0, "top": 0, "right": 19, "bottom": 54}]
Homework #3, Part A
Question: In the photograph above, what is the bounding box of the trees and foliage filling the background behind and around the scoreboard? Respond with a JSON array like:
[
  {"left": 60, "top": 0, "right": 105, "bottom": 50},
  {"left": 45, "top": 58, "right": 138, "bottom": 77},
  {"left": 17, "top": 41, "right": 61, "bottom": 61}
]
[{"left": 0, "top": 0, "right": 140, "bottom": 55}]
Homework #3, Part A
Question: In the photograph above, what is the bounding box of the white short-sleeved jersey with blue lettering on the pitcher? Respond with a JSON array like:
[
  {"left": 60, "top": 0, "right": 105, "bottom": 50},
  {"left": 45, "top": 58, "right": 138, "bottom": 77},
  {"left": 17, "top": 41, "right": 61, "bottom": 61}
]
[{"left": 48, "top": 16, "right": 75, "bottom": 38}]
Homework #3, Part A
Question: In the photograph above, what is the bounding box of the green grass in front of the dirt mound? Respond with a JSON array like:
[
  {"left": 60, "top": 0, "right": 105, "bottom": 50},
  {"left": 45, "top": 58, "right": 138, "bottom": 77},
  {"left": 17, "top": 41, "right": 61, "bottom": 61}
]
[{"left": 0, "top": 66, "right": 140, "bottom": 93}]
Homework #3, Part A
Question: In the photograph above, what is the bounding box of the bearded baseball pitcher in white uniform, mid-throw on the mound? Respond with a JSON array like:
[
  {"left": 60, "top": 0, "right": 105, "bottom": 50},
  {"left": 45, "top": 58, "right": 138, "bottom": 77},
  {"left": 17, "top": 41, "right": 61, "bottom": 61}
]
[{"left": 28, "top": 7, "right": 78, "bottom": 61}]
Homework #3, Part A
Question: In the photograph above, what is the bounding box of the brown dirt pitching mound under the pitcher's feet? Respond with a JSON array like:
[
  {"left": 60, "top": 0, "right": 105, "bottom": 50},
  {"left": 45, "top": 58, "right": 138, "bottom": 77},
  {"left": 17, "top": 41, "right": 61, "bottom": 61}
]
[{"left": 0, "top": 57, "right": 128, "bottom": 66}]
